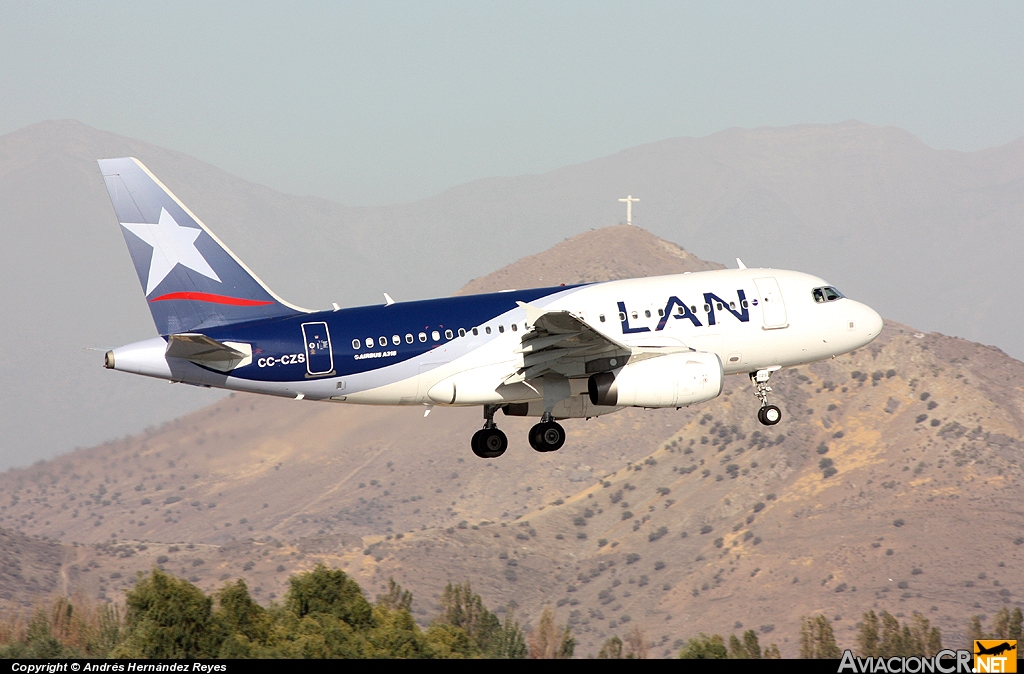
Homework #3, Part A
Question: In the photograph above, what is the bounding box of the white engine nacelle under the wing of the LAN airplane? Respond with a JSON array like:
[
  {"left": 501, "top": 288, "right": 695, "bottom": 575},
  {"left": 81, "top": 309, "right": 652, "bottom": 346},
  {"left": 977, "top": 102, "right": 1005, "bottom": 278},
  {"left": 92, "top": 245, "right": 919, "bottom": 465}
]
[{"left": 588, "top": 351, "right": 725, "bottom": 408}]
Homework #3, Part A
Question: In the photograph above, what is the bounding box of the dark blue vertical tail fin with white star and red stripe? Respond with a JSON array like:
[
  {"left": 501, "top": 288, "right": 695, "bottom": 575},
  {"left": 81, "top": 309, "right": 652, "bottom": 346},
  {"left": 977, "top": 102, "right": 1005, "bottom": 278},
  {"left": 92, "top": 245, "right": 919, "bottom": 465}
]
[{"left": 99, "top": 157, "right": 305, "bottom": 335}]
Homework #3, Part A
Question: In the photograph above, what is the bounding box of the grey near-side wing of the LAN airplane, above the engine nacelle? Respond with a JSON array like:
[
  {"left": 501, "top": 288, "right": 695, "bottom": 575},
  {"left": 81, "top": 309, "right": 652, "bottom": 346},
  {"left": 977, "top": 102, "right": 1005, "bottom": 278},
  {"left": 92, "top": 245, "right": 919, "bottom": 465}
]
[{"left": 506, "top": 302, "right": 632, "bottom": 383}]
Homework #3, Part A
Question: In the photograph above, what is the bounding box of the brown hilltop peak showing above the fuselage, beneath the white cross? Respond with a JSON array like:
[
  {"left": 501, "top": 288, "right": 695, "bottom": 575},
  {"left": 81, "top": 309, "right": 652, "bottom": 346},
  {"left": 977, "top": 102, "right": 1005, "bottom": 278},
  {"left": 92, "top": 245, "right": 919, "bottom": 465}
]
[{"left": 456, "top": 224, "right": 724, "bottom": 295}]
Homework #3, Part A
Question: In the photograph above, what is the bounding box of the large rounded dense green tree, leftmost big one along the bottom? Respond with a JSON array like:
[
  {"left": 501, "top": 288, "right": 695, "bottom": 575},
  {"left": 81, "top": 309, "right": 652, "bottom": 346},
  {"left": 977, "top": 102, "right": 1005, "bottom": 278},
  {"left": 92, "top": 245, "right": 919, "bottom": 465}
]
[{"left": 113, "top": 568, "right": 222, "bottom": 660}]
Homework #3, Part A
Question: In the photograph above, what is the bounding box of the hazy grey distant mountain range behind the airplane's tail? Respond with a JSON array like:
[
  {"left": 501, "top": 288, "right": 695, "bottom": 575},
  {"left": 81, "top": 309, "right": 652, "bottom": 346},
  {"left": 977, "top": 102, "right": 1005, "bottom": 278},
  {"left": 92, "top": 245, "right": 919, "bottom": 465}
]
[{"left": 0, "top": 121, "right": 1024, "bottom": 467}]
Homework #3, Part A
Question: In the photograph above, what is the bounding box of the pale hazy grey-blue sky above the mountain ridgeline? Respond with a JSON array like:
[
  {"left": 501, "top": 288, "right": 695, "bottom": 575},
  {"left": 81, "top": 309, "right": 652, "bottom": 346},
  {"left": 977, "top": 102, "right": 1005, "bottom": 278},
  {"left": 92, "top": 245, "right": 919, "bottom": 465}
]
[{"left": 0, "top": 0, "right": 1024, "bottom": 205}]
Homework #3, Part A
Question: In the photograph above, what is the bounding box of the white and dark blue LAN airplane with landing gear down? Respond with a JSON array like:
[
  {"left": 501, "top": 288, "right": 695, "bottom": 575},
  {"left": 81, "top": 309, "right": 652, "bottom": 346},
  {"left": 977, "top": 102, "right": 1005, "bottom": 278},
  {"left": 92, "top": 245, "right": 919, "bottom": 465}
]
[{"left": 98, "top": 157, "right": 882, "bottom": 459}]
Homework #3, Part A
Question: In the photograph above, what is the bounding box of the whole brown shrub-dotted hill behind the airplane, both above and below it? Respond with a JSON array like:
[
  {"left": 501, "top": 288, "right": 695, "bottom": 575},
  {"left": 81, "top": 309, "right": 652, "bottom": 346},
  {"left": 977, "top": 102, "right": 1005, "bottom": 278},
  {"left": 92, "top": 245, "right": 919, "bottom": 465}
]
[{"left": 0, "top": 227, "right": 1024, "bottom": 656}]
